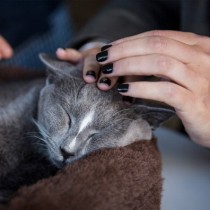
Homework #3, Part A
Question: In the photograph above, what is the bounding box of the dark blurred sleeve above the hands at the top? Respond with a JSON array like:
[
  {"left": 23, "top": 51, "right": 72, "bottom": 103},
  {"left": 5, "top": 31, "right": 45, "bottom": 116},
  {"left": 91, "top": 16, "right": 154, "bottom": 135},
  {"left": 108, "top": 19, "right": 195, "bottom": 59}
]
[{"left": 70, "top": 0, "right": 180, "bottom": 48}]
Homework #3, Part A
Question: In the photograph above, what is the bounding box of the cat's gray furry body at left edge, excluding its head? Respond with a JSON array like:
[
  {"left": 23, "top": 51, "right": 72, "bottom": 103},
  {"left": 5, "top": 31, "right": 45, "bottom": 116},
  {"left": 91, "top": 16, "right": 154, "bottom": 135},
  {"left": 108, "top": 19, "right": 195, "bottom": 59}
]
[{"left": 0, "top": 80, "right": 54, "bottom": 203}]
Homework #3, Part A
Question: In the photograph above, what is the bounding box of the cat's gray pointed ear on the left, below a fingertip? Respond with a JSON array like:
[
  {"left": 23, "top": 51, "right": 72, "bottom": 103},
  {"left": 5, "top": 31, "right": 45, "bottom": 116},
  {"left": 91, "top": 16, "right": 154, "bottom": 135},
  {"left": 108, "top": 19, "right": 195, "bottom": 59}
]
[{"left": 39, "top": 53, "right": 82, "bottom": 83}]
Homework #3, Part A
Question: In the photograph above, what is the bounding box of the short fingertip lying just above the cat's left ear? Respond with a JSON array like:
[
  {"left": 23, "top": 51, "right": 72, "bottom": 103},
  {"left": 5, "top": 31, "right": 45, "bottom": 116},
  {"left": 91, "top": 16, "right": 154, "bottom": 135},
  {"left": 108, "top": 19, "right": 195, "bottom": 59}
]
[{"left": 56, "top": 48, "right": 83, "bottom": 63}]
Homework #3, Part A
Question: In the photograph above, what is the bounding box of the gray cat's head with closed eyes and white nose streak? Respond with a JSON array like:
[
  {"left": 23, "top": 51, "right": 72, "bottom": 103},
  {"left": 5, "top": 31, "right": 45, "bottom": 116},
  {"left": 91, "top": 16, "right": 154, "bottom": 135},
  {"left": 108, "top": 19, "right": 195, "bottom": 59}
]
[{"left": 37, "top": 54, "right": 174, "bottom": 166}]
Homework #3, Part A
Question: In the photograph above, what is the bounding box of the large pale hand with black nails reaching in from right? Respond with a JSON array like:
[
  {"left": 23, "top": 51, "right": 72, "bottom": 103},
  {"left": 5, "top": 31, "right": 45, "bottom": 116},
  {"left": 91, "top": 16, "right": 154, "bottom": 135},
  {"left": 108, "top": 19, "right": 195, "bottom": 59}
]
[{"left": 96, "top": 31, "right": 210, "bottom": 147}]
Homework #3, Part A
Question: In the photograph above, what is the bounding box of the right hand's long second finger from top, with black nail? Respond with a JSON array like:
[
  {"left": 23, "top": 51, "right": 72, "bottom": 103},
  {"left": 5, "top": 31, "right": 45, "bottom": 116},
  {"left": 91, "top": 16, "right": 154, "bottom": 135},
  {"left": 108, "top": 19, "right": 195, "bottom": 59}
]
[{"left": 96, "top": 36, "right": 199, "bottom": 64}]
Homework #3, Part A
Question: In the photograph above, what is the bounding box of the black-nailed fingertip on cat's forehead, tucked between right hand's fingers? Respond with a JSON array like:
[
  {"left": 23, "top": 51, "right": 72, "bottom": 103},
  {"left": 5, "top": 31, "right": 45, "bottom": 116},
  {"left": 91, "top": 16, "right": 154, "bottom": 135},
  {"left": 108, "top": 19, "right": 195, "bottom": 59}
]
[{"left": 97, "top": 74, "right": 118, "bottom": 91}]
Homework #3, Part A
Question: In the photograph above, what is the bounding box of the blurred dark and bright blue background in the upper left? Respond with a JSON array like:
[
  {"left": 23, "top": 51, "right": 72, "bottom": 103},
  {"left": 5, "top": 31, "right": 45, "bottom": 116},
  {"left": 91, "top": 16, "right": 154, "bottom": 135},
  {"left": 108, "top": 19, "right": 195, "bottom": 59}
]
[{"left": 0, "top": 0, "right": 106, "bottom": 71}]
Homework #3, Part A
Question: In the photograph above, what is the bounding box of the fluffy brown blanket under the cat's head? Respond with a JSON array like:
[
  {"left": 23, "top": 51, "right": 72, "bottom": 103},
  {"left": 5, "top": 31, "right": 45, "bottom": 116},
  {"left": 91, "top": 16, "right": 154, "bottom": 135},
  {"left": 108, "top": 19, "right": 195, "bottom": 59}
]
[{"left": 0, "top": 139, "right": 162, "bottom": 210}]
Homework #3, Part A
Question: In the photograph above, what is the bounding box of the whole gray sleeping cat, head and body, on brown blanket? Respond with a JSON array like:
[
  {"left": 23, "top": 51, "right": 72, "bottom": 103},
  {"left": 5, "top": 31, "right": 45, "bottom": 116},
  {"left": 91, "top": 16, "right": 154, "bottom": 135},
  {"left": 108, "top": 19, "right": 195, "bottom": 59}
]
[{"left": 0, "top": 54, "right": 174, "bottom": 202}]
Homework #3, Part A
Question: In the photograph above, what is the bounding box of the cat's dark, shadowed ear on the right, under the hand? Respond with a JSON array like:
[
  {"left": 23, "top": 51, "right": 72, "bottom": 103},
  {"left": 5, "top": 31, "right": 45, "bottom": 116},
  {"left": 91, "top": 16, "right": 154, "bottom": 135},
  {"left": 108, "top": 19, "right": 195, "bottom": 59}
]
[{"left": 132, "top": 101, "right": 175, "bottom": 130}]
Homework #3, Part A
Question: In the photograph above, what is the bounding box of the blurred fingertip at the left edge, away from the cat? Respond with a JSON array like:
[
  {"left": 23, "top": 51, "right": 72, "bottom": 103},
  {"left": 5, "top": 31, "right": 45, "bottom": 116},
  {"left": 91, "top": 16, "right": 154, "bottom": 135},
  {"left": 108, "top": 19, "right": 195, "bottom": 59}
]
[{"left": 0, "top": 35, "right": 13, "bottom": 60}]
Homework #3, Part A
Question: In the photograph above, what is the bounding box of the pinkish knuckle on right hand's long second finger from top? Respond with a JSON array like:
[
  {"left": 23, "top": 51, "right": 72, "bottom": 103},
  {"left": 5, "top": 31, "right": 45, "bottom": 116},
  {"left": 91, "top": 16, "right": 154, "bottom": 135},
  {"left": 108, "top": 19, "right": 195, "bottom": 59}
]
[{"left": 148, "top": 36, "right": 167, "bottom": 52}]
